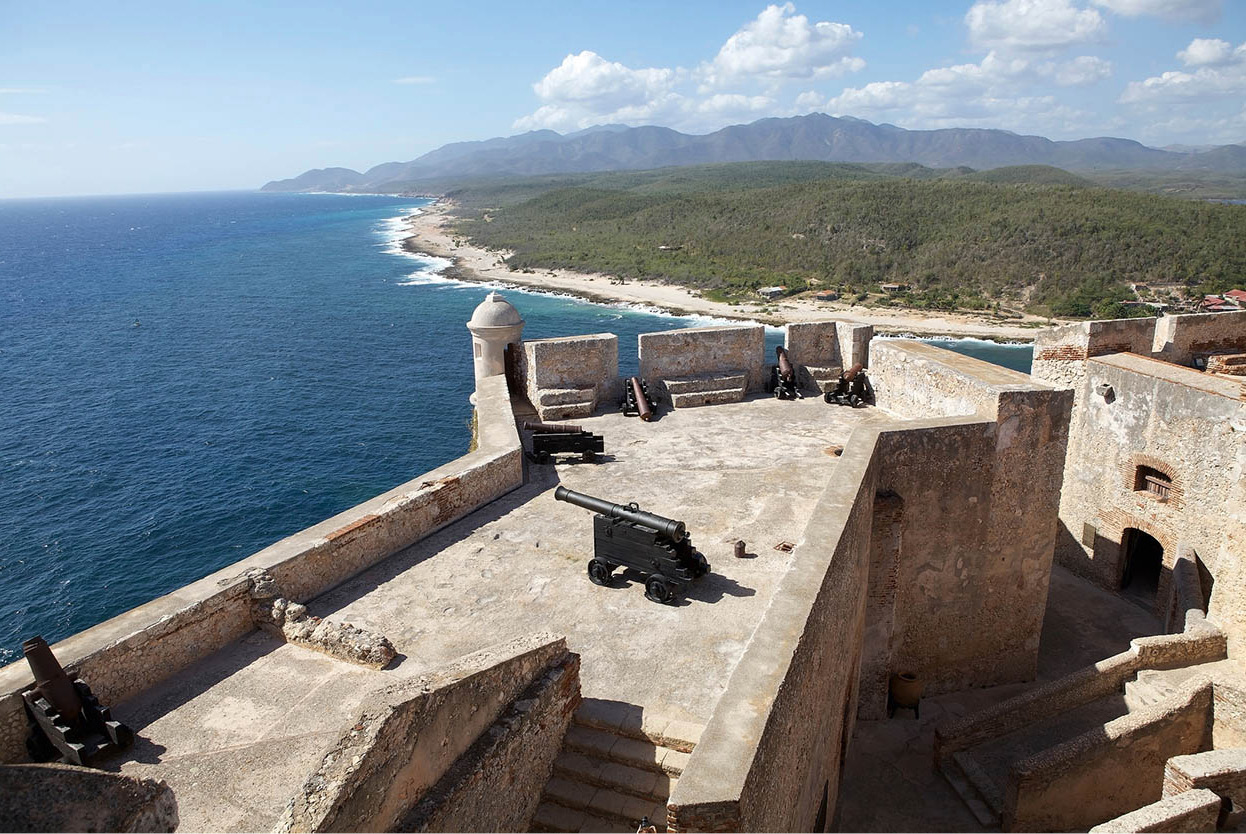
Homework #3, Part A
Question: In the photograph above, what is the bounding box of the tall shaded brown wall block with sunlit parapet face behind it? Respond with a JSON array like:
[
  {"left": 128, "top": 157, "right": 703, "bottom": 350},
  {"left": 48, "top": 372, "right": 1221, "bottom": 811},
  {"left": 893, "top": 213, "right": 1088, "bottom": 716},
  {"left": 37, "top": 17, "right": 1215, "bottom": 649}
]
[{"left": 862, "top": 339, "right": 1072, "bottom": 698}]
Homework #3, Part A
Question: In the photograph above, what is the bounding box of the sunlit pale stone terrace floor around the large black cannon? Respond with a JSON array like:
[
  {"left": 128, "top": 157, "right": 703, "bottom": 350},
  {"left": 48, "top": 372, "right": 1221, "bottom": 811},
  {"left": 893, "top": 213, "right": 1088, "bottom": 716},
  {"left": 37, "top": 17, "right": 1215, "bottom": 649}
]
[{"left": 99, "top": 398, "right": 880, "bottom": 830}]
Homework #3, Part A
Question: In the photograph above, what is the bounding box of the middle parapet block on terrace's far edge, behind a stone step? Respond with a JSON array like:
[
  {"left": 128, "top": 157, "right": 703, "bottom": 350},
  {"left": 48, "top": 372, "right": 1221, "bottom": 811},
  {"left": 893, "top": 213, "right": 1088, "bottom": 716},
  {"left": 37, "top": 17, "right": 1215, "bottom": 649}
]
[{"left": 638, "top": 324, "right": 766, "bottom": 395}]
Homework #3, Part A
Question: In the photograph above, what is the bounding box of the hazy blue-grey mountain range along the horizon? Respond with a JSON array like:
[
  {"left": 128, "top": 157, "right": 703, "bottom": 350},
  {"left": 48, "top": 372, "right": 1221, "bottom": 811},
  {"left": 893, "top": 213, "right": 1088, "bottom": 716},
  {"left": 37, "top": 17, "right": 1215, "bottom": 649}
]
[{"left": 263, "top": 113, "right": 1246, "bottom": 192}]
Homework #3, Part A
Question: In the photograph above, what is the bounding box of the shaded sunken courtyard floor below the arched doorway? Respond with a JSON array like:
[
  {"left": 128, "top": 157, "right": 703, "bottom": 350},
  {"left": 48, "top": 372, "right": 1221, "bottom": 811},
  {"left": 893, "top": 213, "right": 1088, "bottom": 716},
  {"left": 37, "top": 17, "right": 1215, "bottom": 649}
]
[{"left": 837, "top": 566, "right": 1163, "bottom": 832}]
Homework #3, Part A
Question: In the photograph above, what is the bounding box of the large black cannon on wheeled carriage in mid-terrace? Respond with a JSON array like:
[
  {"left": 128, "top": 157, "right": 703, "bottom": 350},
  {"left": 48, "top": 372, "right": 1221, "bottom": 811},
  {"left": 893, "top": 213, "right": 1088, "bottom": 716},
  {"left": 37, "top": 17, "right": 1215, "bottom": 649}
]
[{"left": 553, "top": 486, "right": 709, "bottom": 602}]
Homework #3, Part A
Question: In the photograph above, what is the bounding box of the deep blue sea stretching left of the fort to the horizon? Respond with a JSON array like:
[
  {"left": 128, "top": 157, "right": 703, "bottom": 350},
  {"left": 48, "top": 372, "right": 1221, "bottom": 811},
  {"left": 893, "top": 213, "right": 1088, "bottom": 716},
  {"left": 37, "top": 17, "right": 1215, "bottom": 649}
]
[{"left": 0, "top": 192, "right": 1029, "bottom": 664}]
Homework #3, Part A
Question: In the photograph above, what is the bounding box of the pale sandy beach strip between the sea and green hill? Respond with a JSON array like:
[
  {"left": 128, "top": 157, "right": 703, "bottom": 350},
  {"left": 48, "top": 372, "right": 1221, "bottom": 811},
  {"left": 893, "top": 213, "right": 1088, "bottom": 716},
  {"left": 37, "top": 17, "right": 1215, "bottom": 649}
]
[{"left": 402, "top": 202, "right": 1048, "bottom": 342}]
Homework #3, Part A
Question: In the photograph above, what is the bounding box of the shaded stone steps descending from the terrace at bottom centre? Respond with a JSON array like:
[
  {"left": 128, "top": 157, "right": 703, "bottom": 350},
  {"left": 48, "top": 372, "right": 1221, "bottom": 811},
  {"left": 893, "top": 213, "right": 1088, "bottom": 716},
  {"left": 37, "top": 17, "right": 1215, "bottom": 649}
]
[{"left": 531, "top": 698, "right": 703, "bottom": 833}]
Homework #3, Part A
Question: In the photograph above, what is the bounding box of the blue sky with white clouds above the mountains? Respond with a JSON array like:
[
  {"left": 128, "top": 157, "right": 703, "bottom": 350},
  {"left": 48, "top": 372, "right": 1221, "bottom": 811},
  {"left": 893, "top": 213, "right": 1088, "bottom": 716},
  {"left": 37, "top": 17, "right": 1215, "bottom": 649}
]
[{"left": 0, "top": 0, "right": 1246, "bottom": 197}]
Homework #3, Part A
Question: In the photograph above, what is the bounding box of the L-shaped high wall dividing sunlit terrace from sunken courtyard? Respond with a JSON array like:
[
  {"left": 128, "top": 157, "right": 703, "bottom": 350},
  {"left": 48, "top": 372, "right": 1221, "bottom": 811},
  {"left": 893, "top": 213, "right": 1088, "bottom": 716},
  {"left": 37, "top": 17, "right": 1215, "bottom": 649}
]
[{"left": 669, "top": 371, "right": 1070, "bottom": 830}]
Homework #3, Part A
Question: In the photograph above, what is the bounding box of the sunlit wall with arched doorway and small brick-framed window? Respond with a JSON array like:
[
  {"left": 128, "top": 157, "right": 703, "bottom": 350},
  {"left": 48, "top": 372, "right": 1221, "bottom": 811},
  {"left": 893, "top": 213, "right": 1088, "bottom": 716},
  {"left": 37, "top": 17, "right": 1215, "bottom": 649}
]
[{"left": 1057, "top": 354, "right": 1246, "bottom": 646}]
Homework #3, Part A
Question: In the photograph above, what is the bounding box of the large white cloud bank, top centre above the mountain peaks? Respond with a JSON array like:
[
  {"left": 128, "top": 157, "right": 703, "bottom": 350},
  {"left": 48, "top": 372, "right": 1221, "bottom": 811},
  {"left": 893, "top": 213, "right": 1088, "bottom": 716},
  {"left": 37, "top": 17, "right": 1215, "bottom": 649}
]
[{"left": 515, "top": 2, "right": 865, "bottom": 130}]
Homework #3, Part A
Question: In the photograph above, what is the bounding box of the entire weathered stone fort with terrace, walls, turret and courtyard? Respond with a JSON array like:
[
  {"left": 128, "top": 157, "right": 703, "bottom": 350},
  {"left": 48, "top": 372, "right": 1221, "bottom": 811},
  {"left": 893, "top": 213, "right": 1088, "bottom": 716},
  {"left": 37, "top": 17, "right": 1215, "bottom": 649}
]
[{"left": 0, "top": 299, "right": 1246, "bottom": 832}]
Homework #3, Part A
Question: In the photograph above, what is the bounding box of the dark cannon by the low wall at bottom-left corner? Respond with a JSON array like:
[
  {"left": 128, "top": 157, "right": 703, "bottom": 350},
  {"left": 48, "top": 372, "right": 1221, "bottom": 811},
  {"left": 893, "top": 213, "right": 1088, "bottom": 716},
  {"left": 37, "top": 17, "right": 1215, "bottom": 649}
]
[{"left": 21, "top": 637, "right": 135, "bottom": 767}]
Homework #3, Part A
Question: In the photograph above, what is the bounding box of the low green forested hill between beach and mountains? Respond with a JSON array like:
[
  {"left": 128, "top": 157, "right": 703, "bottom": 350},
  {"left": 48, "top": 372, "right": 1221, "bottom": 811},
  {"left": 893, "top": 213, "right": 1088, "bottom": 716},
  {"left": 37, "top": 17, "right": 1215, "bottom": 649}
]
[{"left": 449, "top": 162, "right": 1246, "bottom": 315}]
